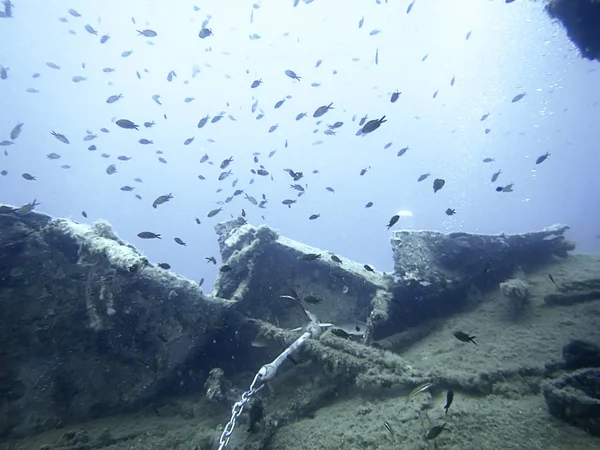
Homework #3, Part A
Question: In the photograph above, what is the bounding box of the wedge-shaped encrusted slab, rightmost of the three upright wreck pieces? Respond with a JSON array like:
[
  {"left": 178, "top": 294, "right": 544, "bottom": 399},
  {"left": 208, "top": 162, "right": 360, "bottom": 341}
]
[{"left": 384, "top": 225, "right": 574, "bottom": 339}]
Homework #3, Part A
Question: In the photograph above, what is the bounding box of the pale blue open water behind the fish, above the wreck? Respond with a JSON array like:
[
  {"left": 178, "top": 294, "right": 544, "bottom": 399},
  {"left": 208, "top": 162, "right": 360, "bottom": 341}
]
[{"left": 0, "top": 0, "right": 600, "bottom": 286}]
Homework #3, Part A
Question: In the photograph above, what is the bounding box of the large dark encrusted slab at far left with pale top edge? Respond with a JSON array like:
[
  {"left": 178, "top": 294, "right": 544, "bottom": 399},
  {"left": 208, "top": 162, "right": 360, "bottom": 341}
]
[{"left": 0, "top": 211, "right": 230, "bottom": 437}]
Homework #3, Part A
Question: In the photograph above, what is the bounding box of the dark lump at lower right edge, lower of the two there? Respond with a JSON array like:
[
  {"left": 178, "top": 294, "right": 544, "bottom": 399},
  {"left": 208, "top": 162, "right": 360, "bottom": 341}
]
[{"left": 542, "top": 369, "right": 600, "bottom": 436}]
